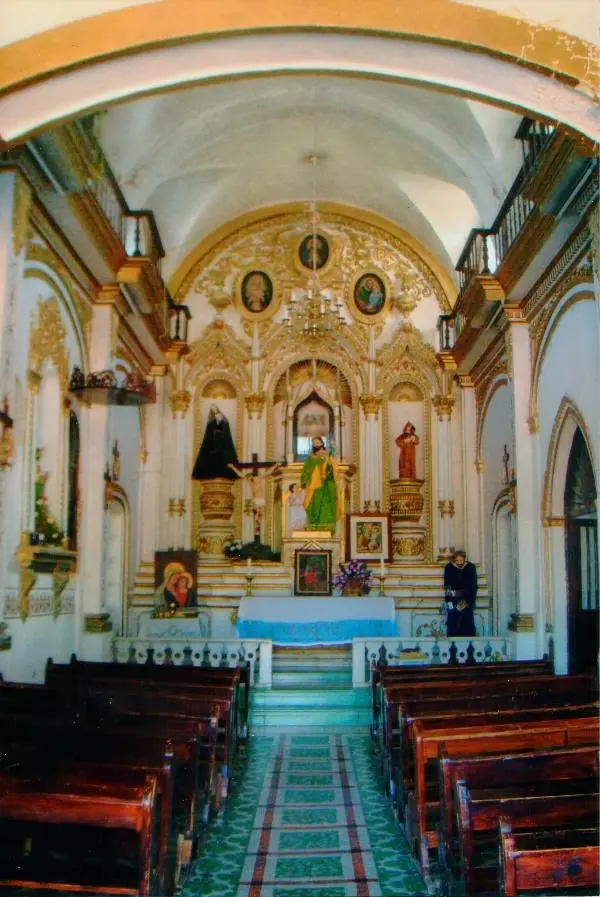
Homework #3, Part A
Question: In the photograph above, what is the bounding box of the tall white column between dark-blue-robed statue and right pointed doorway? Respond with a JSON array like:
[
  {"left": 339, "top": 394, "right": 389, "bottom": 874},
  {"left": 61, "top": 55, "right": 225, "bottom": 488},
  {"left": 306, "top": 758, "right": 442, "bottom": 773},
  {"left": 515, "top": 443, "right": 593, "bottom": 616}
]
[{"left": 504, "top": 303, "right": 541, "bottom": 660}]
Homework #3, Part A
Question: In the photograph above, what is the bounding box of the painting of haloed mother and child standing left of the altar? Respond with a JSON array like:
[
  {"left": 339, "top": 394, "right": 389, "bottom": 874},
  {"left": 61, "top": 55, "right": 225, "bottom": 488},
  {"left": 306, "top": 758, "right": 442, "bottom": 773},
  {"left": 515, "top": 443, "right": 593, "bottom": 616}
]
[{"left": 154, "top": 549, "right": 198, "bottom": 616}]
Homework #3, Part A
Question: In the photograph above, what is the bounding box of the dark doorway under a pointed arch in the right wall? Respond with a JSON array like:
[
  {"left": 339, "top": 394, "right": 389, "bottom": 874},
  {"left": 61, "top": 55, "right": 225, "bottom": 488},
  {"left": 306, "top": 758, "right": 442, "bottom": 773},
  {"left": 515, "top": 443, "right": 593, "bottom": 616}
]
[{"left": 565, "top": 428, "right": 598, "bottom": 673}]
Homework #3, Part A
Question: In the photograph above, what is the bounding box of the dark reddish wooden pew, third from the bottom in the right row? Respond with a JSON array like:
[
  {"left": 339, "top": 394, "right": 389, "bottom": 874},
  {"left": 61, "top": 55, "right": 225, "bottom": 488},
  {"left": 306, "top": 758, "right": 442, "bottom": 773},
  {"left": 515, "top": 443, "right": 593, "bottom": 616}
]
[{"left": 438, "top": 746, "right": 598, "bottom": 874}]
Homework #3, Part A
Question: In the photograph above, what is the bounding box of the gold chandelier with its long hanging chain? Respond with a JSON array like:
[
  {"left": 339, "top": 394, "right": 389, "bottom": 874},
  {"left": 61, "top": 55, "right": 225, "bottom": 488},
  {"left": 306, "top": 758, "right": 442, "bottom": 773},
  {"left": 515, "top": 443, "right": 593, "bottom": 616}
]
[{"left": 282, "top": 153, "right": 348, "bottom": 339}]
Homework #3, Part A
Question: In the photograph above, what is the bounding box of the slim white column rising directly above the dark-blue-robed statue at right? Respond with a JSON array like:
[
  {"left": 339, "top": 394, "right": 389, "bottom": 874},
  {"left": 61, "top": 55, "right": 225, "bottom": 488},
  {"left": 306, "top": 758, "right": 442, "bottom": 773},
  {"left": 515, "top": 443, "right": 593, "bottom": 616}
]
[{"left": 455, "top": 374, "right": 483, "bottom": 564}]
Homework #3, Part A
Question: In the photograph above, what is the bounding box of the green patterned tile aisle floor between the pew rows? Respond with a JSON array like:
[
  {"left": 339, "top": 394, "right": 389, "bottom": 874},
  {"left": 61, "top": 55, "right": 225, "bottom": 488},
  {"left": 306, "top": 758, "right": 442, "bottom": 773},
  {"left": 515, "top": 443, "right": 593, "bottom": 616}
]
[{"left": 182, "top": 729, "right": 427, "bottom": 897}]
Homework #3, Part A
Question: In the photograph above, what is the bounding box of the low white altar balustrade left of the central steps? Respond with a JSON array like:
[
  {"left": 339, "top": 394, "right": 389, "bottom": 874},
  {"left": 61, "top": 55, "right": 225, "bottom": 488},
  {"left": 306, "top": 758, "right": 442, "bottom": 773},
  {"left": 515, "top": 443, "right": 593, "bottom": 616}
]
[{"left": 112, "top": 636, "right": 273, "bottom": 688}]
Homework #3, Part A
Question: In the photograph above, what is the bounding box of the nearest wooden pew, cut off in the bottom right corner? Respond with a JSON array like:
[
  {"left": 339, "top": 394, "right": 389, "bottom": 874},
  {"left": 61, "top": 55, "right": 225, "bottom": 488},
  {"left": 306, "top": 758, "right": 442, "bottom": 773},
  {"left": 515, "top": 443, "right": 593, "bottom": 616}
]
[{"left": 499, "top": 818, "right": 600, "bottom": 897}]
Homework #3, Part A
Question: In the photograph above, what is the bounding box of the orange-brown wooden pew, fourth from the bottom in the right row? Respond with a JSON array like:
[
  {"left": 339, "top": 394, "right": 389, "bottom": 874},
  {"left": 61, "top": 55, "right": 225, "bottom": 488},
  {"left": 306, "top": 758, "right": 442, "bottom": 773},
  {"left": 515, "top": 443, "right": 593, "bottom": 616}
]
[{"left": 406, "top": 707, "right": 598, "bottom": 876}]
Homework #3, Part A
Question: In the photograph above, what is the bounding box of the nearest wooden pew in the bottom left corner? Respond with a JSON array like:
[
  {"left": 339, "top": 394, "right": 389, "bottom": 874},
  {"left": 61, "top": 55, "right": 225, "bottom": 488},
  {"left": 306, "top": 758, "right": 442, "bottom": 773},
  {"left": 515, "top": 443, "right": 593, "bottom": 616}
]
[{"left": 0, "top": 769, "right": 158, "bottom": 897}]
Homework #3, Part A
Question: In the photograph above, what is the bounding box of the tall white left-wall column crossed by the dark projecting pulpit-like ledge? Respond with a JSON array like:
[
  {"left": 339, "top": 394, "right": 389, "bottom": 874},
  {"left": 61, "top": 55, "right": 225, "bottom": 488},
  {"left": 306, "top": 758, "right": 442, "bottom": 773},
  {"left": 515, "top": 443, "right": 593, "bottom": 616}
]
[{"left": 75, "top": 300, "right": 113, "bottom": 660}]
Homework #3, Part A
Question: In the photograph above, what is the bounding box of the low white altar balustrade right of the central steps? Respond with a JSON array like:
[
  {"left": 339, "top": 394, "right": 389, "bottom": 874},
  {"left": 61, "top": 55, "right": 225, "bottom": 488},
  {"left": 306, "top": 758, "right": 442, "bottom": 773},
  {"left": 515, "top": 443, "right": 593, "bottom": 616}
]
[{"left": 352, "top": 635, "right": 512, "bottom": 688}]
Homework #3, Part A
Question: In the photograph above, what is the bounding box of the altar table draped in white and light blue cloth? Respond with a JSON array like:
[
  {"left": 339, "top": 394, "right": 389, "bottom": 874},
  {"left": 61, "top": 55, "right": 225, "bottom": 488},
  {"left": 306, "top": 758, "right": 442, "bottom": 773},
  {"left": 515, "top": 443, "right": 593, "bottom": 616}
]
[{"left": 237, "top": 596, "right": 397, "bottom": 646}]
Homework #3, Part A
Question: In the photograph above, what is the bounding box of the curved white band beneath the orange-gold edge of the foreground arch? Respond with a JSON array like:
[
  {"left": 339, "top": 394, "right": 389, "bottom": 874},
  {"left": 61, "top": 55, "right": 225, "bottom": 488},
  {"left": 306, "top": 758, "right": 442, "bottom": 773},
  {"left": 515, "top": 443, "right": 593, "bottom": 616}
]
[{"left": 0, "top": 32, "right": 600, "bottom": 143}]
